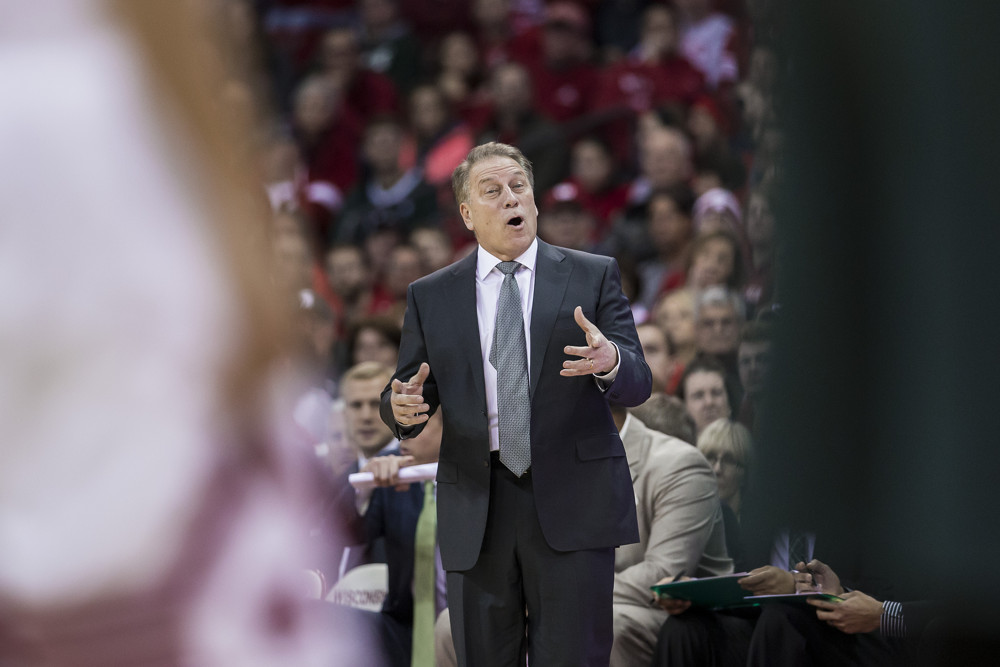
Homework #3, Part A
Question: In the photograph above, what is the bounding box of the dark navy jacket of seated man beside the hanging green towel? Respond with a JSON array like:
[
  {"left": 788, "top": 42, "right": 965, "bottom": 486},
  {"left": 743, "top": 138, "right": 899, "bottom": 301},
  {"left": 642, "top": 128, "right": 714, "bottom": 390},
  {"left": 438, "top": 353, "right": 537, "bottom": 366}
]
[{"left": 365, "top": 449, "right": 424, "bottom": 626}]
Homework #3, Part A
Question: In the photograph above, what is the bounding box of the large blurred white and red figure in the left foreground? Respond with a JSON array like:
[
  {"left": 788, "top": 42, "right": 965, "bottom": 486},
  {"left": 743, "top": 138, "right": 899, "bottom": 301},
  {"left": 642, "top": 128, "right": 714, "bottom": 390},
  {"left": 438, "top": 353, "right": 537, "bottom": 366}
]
[{"left": 0, "top": 0, "right": 365, "bottom": 667}]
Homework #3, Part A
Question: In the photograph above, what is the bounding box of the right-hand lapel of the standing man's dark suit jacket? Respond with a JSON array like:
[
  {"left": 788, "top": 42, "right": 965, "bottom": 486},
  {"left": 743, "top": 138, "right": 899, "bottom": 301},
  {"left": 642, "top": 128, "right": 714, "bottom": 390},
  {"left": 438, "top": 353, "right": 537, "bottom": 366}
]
[{"left": 532, "top": 240, "right": 573, "bottom": 398}]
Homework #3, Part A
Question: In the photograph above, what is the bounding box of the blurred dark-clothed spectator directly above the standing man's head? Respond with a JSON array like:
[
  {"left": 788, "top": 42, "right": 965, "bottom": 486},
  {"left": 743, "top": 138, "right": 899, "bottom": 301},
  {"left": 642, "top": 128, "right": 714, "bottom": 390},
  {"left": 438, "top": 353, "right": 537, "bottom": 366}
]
[{"left": 477, "top": 63, "right": 569, "bottom": 192}]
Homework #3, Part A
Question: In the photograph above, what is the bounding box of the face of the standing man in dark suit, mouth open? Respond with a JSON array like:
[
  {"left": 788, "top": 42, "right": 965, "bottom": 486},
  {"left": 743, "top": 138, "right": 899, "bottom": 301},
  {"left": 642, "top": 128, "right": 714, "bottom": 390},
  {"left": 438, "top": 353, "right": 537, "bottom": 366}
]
[{"left": 459, "top": 157, "right": 538, "bottom": 262}]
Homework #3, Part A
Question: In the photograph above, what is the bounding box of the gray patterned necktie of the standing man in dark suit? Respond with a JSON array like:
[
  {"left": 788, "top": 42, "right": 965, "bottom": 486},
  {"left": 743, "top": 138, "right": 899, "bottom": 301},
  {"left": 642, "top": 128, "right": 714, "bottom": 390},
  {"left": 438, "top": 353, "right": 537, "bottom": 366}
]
[{"left": 490, "top": 262, "right": 531, "bottom": 477}]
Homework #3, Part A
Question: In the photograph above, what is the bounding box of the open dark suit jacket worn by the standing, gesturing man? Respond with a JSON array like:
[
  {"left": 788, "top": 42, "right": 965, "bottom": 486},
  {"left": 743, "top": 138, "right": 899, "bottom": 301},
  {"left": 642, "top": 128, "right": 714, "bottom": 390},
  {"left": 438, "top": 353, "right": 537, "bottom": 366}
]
[{"left": 382, "top": 241, "right": 652, "bottom": 571}]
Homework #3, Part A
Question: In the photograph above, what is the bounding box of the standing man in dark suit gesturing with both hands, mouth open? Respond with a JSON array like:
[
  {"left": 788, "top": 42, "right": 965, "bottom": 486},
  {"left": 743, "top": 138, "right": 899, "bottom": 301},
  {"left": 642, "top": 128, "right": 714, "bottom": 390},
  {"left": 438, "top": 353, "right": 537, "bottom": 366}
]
[{"left": 382, "top": 143, "right": 651, "bottom": 667}]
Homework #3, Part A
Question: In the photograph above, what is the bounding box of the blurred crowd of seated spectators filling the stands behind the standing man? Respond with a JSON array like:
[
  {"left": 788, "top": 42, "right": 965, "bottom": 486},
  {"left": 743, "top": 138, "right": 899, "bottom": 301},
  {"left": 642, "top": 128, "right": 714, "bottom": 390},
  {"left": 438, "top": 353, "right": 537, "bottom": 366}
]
[{"left": 203, "top": 0, "right": 928, "bottom": 665}]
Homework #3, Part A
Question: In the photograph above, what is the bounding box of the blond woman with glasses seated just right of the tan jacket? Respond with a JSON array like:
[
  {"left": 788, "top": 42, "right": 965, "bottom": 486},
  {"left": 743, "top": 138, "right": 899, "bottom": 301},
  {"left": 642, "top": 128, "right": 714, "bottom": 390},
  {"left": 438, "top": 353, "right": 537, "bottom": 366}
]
[{"left": 698, "top": 419, "right": 753, "bottom": 572}]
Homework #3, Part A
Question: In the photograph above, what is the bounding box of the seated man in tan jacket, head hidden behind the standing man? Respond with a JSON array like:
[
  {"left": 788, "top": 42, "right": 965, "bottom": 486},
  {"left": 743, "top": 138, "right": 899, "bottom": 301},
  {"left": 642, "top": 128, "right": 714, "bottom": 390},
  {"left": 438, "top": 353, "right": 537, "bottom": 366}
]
[{"left": 611, "top": 406, "right": 733, "bottom": 667}]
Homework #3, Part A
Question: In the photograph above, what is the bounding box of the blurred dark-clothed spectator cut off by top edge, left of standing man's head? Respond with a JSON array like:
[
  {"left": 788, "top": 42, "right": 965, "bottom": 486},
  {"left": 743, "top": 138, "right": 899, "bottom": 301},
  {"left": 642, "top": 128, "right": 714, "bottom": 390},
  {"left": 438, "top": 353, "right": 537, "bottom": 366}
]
[{"left": 358, "top": 0, "right": 420, "bottom": 93}]
